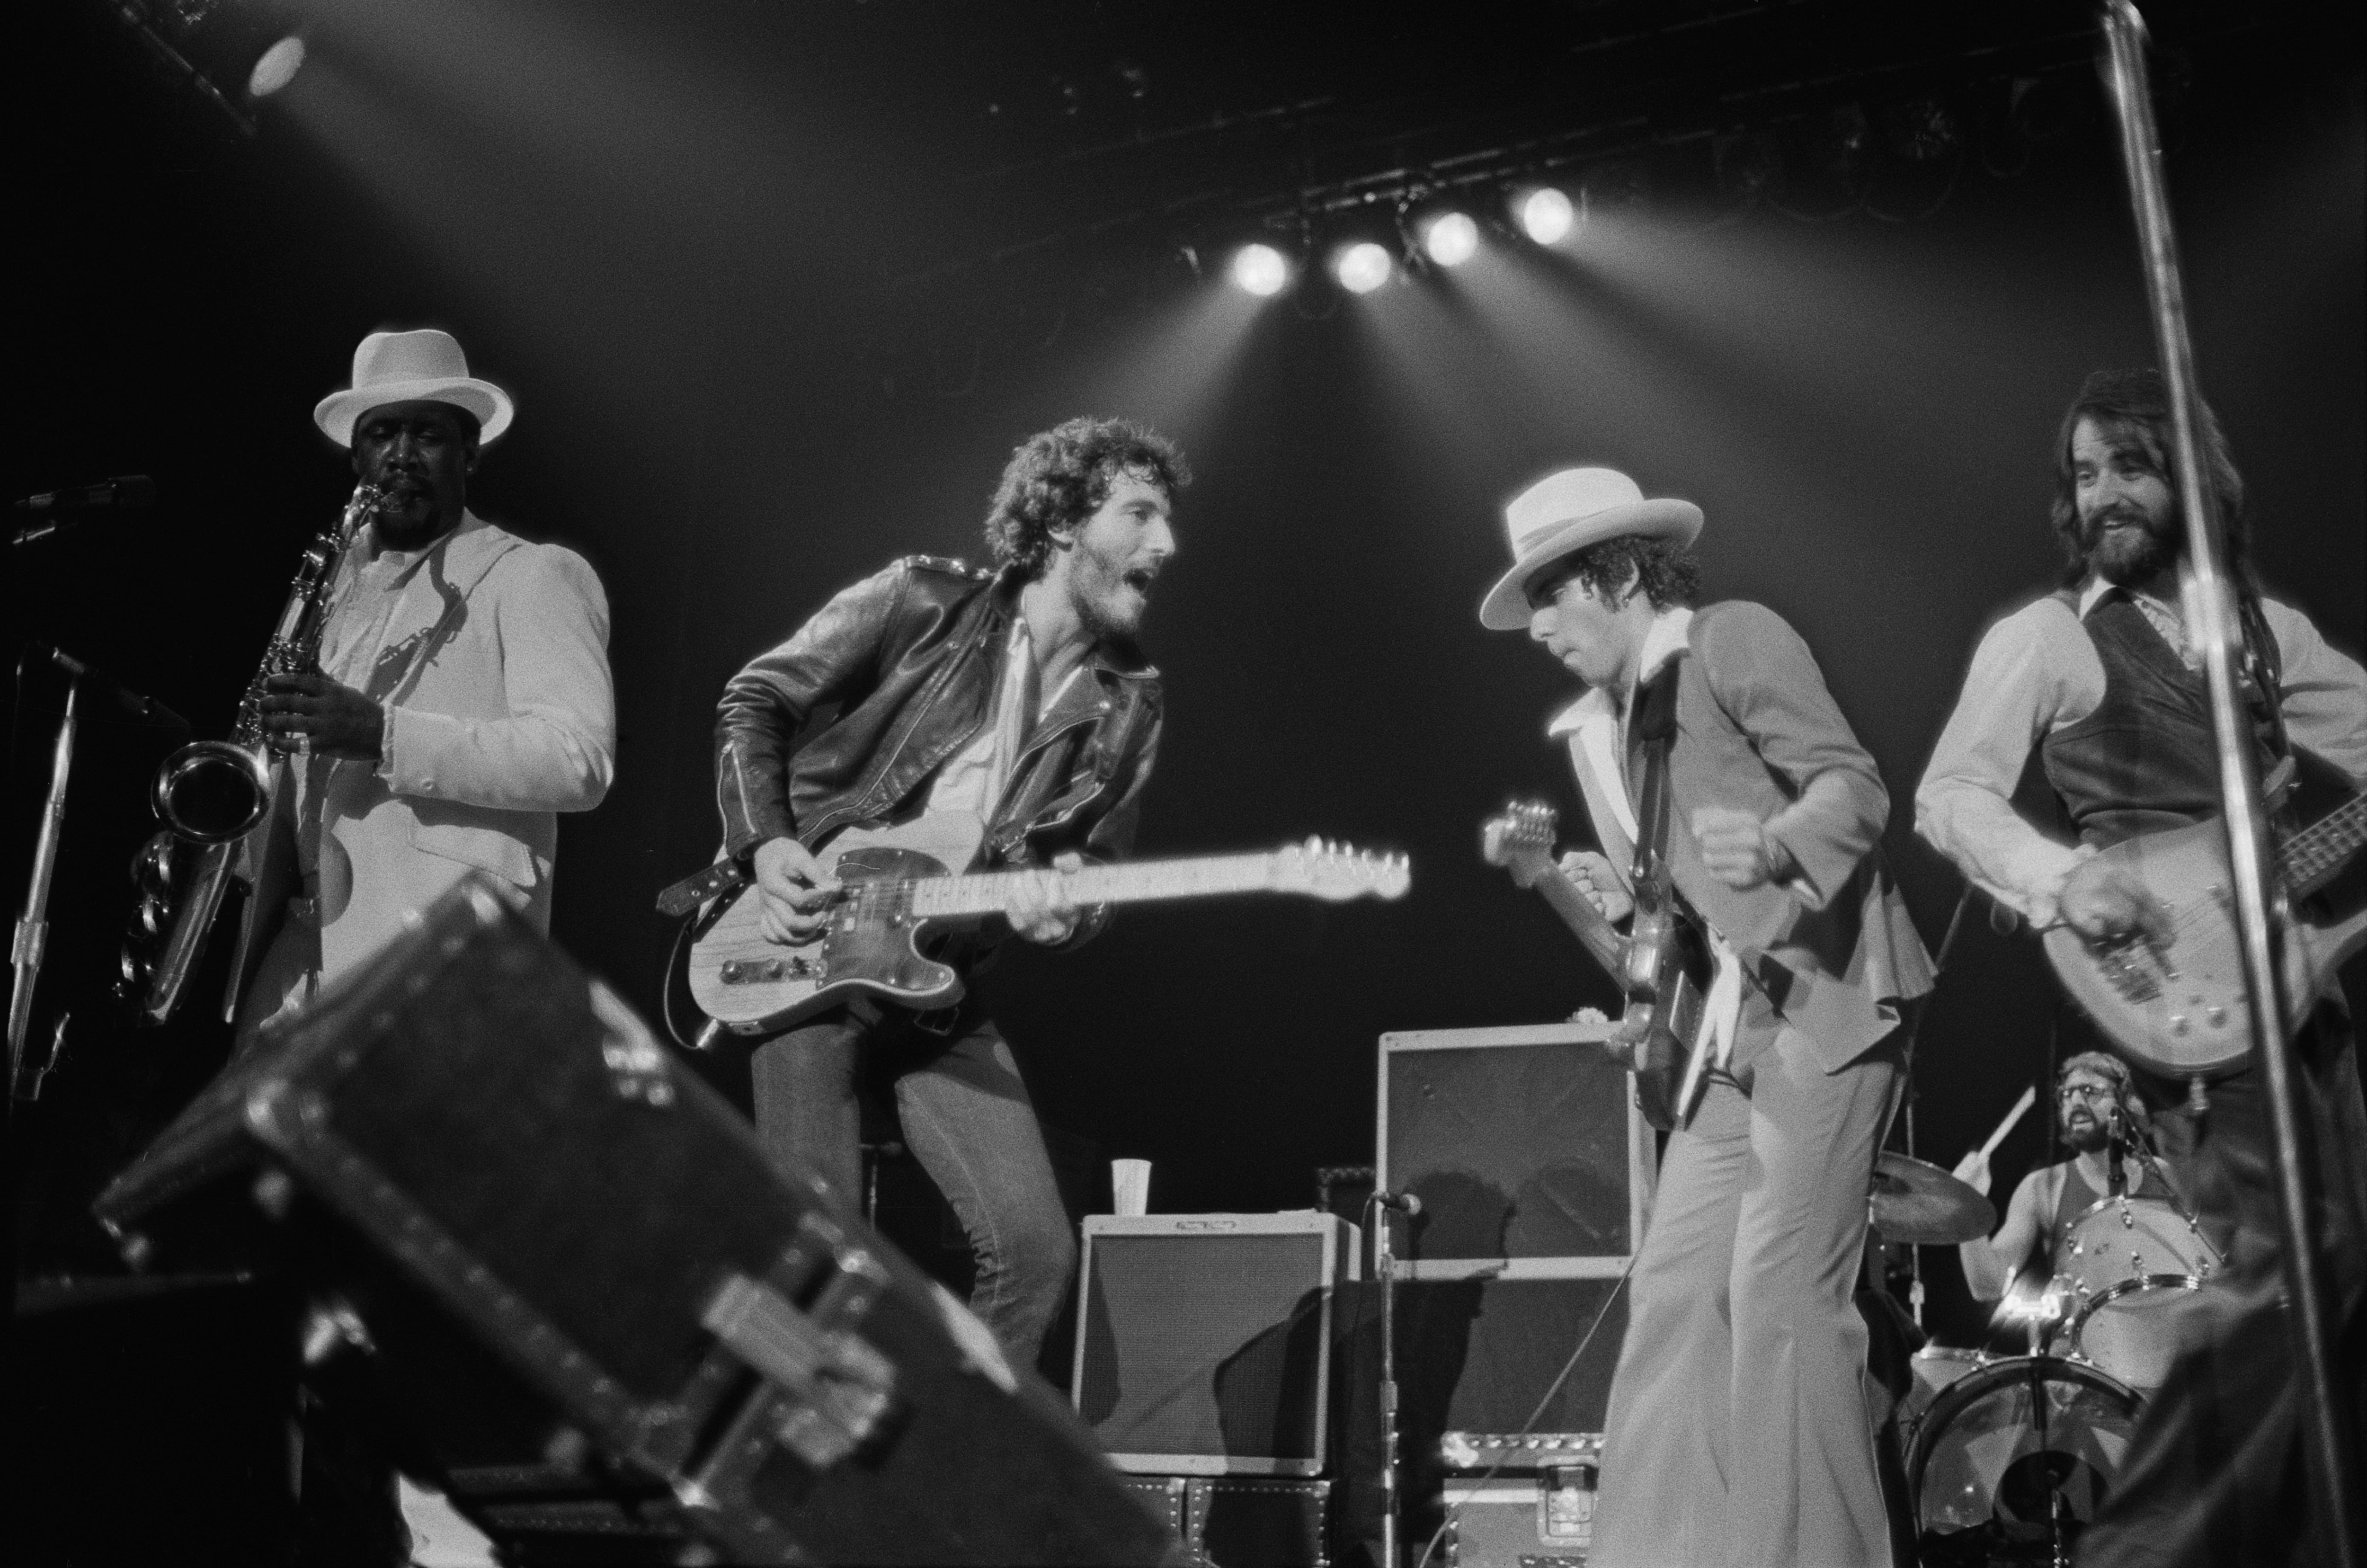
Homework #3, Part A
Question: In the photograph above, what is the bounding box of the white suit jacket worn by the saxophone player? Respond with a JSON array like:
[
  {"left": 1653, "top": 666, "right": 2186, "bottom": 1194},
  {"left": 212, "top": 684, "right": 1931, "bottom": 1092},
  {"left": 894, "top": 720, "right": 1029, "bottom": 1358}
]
[{"left": 232, "top": 514, "right": 615, "bottom": 1011}]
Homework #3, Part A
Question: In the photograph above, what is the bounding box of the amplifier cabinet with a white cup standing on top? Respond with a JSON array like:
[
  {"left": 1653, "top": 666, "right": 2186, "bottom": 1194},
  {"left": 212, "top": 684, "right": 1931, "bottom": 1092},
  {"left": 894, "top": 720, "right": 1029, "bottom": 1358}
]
[{"left": 1070, "top": 1213, "right": 1356, "bottom": 1476}]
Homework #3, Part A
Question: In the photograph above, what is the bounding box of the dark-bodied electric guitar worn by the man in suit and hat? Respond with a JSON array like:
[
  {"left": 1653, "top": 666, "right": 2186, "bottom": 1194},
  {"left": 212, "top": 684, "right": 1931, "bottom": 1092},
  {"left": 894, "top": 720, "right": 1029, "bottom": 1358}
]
[{"left": 1479, "top": 801, "right": 1709, "bottom": 1132}]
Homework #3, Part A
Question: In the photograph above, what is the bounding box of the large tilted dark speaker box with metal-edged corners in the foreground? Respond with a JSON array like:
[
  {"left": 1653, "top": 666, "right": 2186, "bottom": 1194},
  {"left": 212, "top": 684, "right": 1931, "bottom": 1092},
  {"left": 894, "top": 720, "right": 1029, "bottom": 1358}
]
[{"left": 99, "top": 879, "right": 1176, "bottom": 1563}]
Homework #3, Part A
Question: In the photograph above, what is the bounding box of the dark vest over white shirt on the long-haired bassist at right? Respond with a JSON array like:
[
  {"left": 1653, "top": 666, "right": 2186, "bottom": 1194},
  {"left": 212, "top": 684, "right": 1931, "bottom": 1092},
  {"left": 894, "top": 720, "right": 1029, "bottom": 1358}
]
[{"left": 2038, "top": 592, "right": 2272, "bottom": 848}]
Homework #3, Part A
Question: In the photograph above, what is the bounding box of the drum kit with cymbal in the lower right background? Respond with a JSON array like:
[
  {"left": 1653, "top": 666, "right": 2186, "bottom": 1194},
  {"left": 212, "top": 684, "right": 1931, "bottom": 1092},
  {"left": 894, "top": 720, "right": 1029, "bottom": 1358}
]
[{"left": 1868, "top": 1153, "right": 2218, "bottom": 1568}]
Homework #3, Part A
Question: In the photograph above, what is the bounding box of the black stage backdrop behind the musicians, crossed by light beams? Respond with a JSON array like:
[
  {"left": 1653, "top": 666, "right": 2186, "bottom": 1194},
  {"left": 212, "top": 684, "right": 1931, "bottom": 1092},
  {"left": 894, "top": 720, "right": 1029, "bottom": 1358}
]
[{"left": 18, "top": 0, "right": 2367, "bottom": 1338}]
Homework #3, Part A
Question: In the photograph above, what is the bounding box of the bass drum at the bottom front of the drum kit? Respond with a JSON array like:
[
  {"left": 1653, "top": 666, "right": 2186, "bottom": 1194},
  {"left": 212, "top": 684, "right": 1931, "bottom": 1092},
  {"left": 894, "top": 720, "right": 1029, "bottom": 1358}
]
[{"left": 1908, "top": 1355, "right": 2140, "bottom": 1568}]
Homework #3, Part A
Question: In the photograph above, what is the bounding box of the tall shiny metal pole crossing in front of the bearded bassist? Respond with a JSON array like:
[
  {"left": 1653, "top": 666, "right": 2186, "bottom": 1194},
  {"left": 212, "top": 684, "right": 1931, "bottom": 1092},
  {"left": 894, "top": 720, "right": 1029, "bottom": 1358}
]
[{"left": 2104, "top": 0, "right": 2358, "bottom": 1563}]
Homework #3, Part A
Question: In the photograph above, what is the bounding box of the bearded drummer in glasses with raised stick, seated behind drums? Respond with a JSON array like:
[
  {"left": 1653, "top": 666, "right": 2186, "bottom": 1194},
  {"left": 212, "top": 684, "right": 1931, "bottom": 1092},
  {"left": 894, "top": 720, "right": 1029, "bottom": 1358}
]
[{"left": 1955, "top": 1051, "right": 2171, "bottom": 1301}]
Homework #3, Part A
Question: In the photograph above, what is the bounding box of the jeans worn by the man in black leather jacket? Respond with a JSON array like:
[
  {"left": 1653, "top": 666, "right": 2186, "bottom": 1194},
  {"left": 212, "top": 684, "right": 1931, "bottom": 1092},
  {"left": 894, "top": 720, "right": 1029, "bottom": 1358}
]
[{"left": 750, "top": 1002, "right": 1077, "bottom": 1367}]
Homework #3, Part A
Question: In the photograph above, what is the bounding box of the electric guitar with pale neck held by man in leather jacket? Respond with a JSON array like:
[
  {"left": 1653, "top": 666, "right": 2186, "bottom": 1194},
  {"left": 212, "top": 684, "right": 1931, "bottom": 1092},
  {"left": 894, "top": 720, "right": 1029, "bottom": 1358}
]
[{"left": 660, "top": 815, "right": 1411, "bottom": 1035}]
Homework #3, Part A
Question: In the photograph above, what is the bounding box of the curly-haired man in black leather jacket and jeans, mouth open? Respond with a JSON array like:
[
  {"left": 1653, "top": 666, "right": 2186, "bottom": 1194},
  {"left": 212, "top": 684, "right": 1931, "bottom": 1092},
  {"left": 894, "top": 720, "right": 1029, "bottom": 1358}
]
[{"left": 715, "top": 419, "right": 1188, "bottom": 1364}]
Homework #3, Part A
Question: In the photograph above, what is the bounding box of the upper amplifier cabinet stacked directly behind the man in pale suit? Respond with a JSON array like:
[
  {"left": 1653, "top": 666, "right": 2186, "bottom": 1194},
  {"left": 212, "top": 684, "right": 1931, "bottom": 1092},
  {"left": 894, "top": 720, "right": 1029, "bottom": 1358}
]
[{"left": 1375, "top": 1023, "right": 1657, "bottom": 1279}]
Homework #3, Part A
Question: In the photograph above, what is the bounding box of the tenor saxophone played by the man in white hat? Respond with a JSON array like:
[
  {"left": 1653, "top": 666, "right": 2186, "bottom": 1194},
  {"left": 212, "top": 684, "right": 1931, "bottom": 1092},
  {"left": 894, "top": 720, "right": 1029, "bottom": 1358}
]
[{"left": 116, "top": 481, "right": 381, "bottom": 1025}]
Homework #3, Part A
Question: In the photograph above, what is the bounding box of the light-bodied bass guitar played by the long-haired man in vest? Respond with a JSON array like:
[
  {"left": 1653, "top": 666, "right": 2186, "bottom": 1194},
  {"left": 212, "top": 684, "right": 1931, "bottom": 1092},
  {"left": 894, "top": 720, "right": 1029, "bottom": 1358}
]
[{"left": 2045, "top": 793, "right": 2367, "bottom": 1078}]
